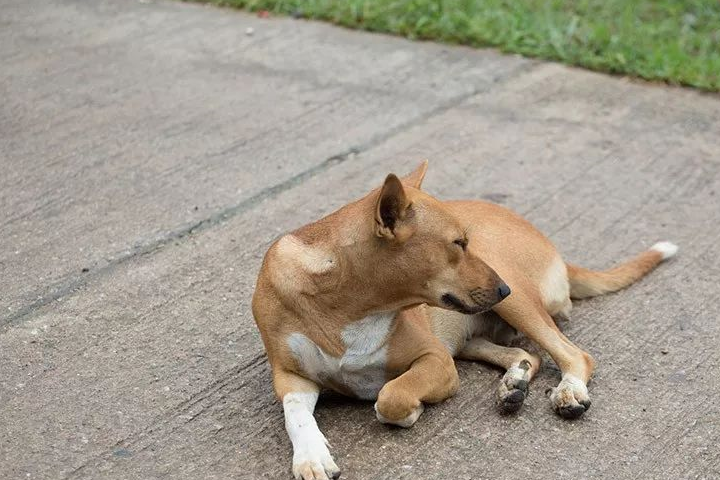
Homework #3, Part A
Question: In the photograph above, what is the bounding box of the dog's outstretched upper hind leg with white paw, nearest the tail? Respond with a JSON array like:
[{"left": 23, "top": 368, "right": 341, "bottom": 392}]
[{"left": 494, "top": 281, "right": 595, "bottom": 418}]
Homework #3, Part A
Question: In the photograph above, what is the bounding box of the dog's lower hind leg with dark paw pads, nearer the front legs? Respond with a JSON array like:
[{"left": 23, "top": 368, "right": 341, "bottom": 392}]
[{"left": 457, "top": 337, "right": 541, "bottom": 413}]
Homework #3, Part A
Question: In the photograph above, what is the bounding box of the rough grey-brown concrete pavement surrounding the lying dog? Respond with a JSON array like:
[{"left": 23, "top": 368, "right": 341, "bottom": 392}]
[{"left": 0, "top": 0, "right": 720, "bottom": 479}]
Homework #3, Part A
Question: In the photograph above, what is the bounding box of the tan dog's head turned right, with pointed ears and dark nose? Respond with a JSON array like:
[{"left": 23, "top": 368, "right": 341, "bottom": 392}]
[{"left": 371, "top": 162, "right": 510, "bottom": 314}]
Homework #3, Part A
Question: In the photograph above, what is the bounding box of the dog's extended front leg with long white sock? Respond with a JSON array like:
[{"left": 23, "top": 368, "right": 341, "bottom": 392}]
[{"left": 274, "top": 372, "right": 340, "bottom": 480}]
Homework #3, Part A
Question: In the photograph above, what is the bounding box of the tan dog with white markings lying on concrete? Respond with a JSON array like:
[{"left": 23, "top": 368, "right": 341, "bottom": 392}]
[{"left": 252, "top": 161, "right": 677, "bottom": 480}]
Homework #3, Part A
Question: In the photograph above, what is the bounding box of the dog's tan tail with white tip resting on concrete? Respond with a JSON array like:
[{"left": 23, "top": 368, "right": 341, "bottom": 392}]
[{"left": 567, "top": 242, "right": 678, "bottom": 298}]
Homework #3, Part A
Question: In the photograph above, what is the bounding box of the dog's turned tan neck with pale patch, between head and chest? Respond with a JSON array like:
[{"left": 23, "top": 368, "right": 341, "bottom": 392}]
[{"left": 280, "top": 197, "right": 422, "bottom": 321}]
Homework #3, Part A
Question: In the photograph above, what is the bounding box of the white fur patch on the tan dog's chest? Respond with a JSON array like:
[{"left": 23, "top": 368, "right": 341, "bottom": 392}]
[{"left": 287, "top": 312, "right": 395, "bottom": 400}]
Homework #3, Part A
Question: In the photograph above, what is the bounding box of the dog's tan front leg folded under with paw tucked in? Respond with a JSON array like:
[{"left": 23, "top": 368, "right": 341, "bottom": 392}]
[{"left": 375, "top": 350, "right": 460, "bottom": 428}]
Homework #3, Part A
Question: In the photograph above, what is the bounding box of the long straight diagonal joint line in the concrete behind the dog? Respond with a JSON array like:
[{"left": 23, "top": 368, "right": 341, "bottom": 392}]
[{"left": 0, "top": 61, "right": 542, "bottom": 334}]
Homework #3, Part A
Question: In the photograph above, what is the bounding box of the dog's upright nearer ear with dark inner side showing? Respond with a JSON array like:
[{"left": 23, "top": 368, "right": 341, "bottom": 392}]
[{"left": 375, "top": 173, "right": 410, "bottom": 241}]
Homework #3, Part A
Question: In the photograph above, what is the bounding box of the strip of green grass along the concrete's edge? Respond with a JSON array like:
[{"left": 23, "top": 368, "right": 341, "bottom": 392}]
[{"left": 198, "top": 0, "right": 720, "bottom": 91}]
